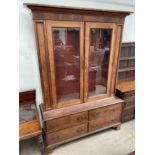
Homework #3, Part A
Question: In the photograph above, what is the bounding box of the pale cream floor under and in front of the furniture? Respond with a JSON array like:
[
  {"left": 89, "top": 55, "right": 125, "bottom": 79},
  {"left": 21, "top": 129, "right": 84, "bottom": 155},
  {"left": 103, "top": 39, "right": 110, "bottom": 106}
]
[{"left": 20, "top": 120, "right": 135, "bottom": 155}]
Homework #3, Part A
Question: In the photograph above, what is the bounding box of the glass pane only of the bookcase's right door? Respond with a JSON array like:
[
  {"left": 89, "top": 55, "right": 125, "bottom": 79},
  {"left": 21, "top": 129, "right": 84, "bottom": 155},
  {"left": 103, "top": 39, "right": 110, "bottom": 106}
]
[{"left": 88, "top": 28, "right": 112, "bottom": 96}]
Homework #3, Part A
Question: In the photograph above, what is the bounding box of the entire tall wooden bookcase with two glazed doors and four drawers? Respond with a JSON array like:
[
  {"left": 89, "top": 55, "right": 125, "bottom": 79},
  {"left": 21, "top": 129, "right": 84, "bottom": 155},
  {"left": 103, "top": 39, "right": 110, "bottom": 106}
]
[{"left": 26, "top": 4, "right": 130, "bottom": 153}]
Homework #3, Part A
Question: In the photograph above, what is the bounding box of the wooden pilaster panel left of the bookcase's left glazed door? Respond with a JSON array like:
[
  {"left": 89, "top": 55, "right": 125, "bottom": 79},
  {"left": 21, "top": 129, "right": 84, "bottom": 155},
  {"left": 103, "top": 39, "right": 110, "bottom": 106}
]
[{"left": 35, "top": 21, "right": 52, "bottom": 109}]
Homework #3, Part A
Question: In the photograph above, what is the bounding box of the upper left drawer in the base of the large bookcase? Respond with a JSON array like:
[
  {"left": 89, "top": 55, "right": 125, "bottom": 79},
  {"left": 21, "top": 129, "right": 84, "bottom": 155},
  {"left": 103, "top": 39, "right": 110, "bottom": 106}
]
[{"left": 46, "top": 112, "right": 88, "bottom": 132}]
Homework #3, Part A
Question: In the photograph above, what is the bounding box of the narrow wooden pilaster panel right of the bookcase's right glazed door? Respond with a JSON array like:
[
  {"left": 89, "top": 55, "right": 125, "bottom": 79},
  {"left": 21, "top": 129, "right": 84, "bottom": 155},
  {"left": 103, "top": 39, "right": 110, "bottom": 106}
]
[{"left": 111, "top": 25, "right": 123, "bottom": 95}]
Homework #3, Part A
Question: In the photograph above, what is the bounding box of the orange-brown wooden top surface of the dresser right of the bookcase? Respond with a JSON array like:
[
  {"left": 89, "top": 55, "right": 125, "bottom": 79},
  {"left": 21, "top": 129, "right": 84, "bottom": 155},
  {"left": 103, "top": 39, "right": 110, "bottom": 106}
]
[{"left": 116, "top": 78, "right": 135, "bottom": 93}]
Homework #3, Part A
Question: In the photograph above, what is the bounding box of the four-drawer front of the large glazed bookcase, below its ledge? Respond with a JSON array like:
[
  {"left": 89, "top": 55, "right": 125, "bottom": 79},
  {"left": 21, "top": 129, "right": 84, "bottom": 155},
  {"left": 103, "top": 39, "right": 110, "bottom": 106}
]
[{"left": 41, "top": 100, "right": 123, "bottom": 149}]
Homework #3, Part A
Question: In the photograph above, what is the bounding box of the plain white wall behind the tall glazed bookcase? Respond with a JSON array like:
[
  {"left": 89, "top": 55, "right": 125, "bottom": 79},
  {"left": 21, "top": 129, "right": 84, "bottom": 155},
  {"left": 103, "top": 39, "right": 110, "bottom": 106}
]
[{"left": 19, "top": 0, "right": 135, "bottom": 104}]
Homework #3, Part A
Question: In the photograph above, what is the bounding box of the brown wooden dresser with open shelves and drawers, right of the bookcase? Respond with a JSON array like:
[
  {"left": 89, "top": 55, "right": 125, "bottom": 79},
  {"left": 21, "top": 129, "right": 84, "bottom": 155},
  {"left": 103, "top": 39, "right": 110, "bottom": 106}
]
[{"left": 116, "top": 42, "right": 135, "bottom": 122}]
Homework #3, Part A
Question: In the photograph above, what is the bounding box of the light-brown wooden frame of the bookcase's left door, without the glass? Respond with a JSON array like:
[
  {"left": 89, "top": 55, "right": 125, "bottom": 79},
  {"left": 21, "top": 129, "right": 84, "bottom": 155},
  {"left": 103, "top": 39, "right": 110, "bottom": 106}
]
[{"left": 46, "top": 20, "right": 84, "bottom": 108}]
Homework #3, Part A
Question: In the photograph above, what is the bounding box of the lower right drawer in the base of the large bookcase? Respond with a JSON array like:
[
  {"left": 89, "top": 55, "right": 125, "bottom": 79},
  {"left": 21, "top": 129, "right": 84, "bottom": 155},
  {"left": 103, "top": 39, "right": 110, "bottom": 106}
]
[{"left": 89, "top": 113, "right": 121, "bottom": 132}]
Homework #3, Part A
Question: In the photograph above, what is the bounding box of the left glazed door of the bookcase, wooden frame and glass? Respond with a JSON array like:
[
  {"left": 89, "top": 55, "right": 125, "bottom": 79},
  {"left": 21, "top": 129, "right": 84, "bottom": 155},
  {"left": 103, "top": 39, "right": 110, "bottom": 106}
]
[{"left": 46, "top": 20, "right": 84, "bottom": 108}]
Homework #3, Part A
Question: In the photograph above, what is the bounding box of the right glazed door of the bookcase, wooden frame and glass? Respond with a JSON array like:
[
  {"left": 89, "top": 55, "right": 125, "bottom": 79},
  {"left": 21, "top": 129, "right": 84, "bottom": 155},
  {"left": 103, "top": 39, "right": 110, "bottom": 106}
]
[{"left": 84, "top": 22, "right": 116, "bottom": 102}]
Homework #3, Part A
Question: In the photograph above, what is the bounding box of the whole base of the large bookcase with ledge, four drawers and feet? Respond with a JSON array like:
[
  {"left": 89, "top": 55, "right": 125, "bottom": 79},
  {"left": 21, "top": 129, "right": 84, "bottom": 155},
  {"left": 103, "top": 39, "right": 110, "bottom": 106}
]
[{"left": 41, "top": 98, "right": 123, "bottom": 152}]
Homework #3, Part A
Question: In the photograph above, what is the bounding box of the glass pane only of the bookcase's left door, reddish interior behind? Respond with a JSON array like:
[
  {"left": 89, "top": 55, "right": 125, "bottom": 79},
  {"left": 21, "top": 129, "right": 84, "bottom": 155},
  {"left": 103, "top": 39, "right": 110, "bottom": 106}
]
[{"left": 52, "top": 28, "right": 80, "bottom": 102}]
